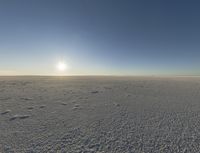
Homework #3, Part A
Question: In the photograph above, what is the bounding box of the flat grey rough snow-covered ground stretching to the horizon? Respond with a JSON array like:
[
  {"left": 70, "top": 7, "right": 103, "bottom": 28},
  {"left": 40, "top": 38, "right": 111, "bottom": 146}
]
[{"left": 0, "top": 77, "right": 200, "bottom": 153}]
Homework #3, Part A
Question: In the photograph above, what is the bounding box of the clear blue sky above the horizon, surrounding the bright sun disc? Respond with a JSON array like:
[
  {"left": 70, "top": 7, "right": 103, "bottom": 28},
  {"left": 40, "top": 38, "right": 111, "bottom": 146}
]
[{"left": 0, "top": 0, "right": 200, "bottom": 75}]
